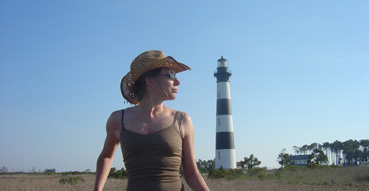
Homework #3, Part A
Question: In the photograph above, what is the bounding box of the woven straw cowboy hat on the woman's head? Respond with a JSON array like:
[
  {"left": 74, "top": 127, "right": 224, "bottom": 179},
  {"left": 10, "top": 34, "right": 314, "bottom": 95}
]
[{"left": 120, "top": 50, "right": 191, "bottom": 104}]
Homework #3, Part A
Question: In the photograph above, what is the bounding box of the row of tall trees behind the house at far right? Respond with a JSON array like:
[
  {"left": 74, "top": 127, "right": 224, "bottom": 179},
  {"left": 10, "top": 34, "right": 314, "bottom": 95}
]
[{"left": 293, "top": 139, "right": 369, "bottom": 166}]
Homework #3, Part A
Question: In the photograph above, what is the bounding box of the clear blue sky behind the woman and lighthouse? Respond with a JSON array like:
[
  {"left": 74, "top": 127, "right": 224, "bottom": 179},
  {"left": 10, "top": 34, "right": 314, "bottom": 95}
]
[{"left": 0, "top": 0, "right": 369, "bottom": 172}]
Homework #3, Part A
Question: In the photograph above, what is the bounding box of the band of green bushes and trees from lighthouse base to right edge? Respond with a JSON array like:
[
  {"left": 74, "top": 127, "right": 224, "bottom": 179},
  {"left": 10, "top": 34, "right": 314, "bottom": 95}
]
[{"left": 197, "top": 139, "right": 369, "bottom": 181}]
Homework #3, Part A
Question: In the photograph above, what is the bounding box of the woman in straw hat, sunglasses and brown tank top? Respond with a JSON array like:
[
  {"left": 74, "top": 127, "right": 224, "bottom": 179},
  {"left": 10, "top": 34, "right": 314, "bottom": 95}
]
[{"left": 95, "top": 50, "right": 209, "bottom": 191}]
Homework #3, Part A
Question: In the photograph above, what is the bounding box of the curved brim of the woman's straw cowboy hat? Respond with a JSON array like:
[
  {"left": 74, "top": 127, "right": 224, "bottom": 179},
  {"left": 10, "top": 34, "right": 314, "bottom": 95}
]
[{"left": 120, "top": 56, "right": 191, "bottom": 104}]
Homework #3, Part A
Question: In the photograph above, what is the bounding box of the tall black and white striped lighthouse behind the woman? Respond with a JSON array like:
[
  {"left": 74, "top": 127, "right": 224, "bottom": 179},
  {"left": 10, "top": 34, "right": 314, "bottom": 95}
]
[{"left": 214, "top": 56, "right": 236, "bottom": 169}]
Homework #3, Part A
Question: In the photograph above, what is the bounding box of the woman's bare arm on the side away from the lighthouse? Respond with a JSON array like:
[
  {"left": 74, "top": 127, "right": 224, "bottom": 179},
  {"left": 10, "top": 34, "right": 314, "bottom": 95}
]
[{"left": 94, "top": 111, "right": 121, "bottom": 191}]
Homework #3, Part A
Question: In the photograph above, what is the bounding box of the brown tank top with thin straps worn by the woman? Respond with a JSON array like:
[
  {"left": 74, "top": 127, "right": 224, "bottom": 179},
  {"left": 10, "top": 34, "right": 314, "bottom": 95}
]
[{"left": 120, "top": 110, "right": 183, "bottom": 191}]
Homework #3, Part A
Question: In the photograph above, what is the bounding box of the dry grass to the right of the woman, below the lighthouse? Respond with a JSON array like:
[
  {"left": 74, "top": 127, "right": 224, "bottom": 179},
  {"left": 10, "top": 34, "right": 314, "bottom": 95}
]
[{"left": 201, "top": 167, "right": 369, "bottom": 191}]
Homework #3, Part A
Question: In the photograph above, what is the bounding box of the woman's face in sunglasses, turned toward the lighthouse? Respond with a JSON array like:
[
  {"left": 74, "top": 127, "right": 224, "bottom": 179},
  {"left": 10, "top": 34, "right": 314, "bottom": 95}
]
[{"left": 157, "top": 68, "right": 181, "bottom": 100}]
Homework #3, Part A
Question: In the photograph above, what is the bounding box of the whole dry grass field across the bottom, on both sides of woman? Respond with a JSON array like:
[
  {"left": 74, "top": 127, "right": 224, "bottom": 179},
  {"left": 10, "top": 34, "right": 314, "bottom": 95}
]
[{"left": 0, "top": 167, "right": 369, "bottom": 191}]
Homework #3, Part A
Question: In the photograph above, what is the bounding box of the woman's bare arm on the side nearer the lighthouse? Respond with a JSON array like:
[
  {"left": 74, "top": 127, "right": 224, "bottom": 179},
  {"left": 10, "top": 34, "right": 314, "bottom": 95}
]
[{"left": 182, "top": 114, "right": 209, "bottom": 191}]
